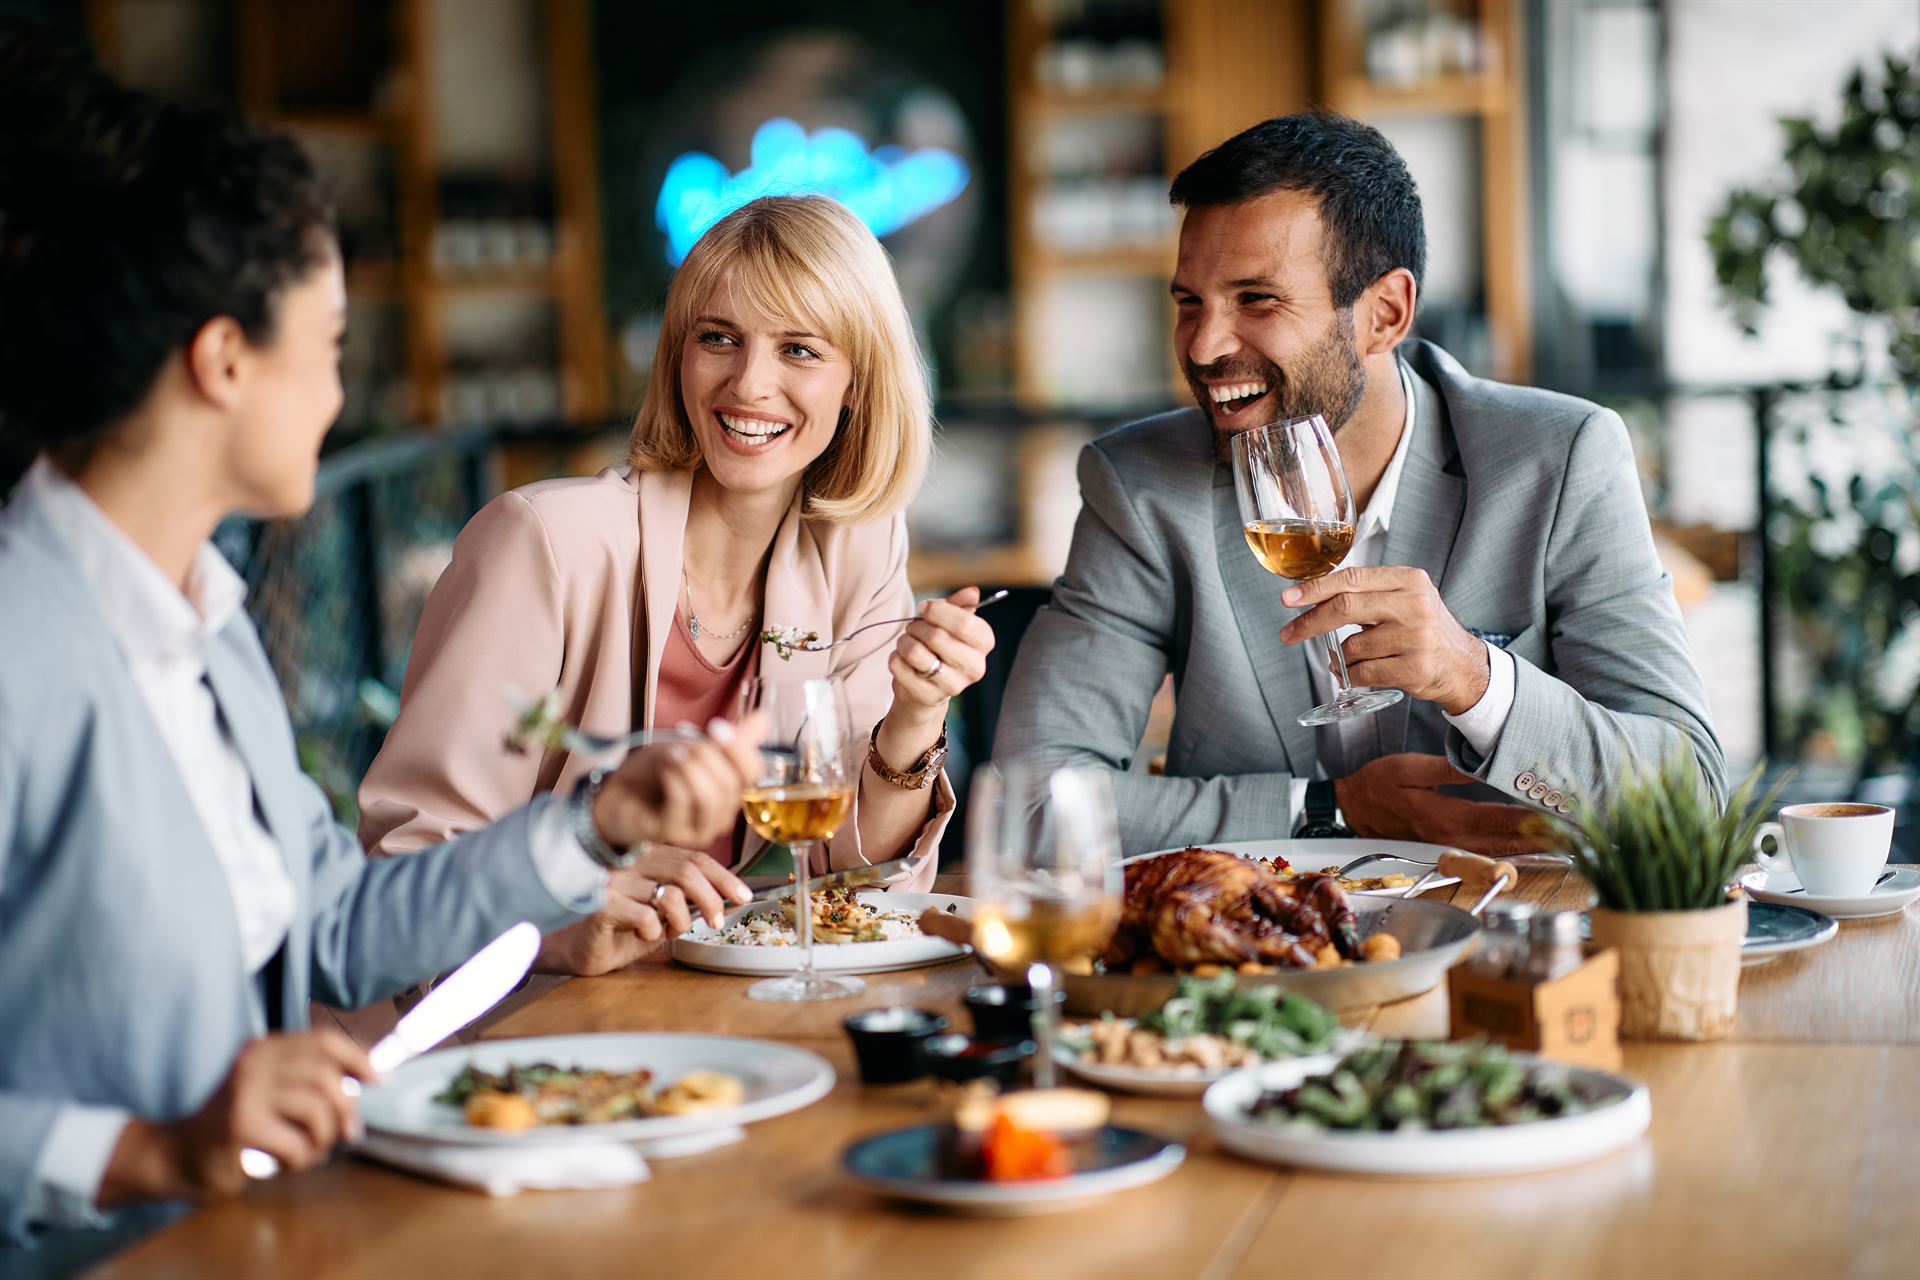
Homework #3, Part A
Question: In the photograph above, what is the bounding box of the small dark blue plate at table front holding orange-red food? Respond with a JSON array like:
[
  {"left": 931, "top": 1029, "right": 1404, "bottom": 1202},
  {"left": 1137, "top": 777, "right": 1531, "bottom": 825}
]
[{"left": 841, "top": 1125, "right": 1187, "bottom": 1215}]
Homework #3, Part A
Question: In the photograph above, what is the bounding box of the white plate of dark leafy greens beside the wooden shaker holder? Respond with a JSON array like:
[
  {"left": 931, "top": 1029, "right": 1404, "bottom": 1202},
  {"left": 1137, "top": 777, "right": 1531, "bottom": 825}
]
[{"left": 1204, "top": 1040, "right": 1653, "bottom": 1178}]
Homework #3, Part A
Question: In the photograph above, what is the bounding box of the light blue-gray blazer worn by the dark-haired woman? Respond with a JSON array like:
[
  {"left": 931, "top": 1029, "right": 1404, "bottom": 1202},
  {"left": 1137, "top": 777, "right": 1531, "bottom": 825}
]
[{"left": 0, "top": 503, "right": 591, "bottom": 1270}]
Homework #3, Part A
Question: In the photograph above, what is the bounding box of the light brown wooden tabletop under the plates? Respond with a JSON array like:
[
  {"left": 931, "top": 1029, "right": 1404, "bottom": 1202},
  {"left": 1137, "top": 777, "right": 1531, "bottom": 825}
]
[{"left": 96, "top": 873, "right": 1920, "bottom": 1280}]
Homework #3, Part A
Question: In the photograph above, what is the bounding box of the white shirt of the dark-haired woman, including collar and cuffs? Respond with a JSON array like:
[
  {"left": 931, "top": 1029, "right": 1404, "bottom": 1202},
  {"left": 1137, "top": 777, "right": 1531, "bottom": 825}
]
[{"left": 13, "top": 457, "right": 607, "bottom": 1226}]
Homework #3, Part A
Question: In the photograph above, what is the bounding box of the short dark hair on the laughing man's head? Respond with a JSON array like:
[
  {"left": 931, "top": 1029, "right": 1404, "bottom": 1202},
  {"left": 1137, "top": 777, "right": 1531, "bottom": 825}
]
[{"left": 1169, "top": 111, "right": 1427, "bottom": 307}]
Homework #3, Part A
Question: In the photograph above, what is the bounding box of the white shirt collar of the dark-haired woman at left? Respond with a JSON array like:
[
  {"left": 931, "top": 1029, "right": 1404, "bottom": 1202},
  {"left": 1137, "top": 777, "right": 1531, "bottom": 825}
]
[{"left": 13, "top": 455, "right": 246, "bottom": 668}]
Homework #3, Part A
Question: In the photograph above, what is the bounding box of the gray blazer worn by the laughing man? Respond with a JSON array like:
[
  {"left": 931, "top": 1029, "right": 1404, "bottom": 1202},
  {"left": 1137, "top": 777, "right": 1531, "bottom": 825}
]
[{"left": 995, "top": 342, "right": 1726, "bottom": 852}]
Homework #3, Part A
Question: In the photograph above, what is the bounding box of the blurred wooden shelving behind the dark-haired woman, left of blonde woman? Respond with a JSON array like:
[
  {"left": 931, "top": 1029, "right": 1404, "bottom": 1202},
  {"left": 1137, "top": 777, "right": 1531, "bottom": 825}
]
[{"left": 88, "top": 0, "right": 611, "bottom": 445}]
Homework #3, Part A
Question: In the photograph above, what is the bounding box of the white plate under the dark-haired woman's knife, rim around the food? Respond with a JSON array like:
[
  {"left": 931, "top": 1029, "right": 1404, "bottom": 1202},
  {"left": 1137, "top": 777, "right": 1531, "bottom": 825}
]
[{"left": 359, "top": 1032, "right": 833, "bottom": 1146}]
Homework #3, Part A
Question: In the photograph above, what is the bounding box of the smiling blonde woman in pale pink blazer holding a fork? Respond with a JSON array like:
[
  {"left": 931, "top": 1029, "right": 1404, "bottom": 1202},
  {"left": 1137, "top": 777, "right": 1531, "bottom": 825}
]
[{"left": 359, "top": 196, "right": 993, "bottom": 973}]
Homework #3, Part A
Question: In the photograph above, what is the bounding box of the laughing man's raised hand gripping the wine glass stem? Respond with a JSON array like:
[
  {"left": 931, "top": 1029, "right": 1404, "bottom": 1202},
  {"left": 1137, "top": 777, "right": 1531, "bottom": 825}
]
[{"left": 1281, "top": 564, "right": 1490, "bottom": 716}]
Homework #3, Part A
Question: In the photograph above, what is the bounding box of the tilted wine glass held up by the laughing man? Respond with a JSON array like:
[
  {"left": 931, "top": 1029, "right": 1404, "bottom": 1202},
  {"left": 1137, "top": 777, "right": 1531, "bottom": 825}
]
[{"left": 1233, "top": 413, "right": 1407, "bottom": 725}]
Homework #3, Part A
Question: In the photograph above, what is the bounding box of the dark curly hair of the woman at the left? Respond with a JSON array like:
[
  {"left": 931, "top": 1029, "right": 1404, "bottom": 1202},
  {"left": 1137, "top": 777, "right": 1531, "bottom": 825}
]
[{"left": 0, "top": 25, "right": 338, "bottom": 466}]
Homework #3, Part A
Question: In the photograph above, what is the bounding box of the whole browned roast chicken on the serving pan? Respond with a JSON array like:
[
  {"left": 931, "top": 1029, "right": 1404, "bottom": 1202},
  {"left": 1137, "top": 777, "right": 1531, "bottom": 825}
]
[{"left": 1102, "top": 848, "right": 1361, "bottom": 971}]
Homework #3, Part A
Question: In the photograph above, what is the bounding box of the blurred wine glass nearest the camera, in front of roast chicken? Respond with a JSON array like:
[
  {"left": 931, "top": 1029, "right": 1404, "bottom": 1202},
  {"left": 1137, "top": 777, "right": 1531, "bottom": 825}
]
[{"left": 966, "top": 766, "right": 1121, "bottom": 1088}]
